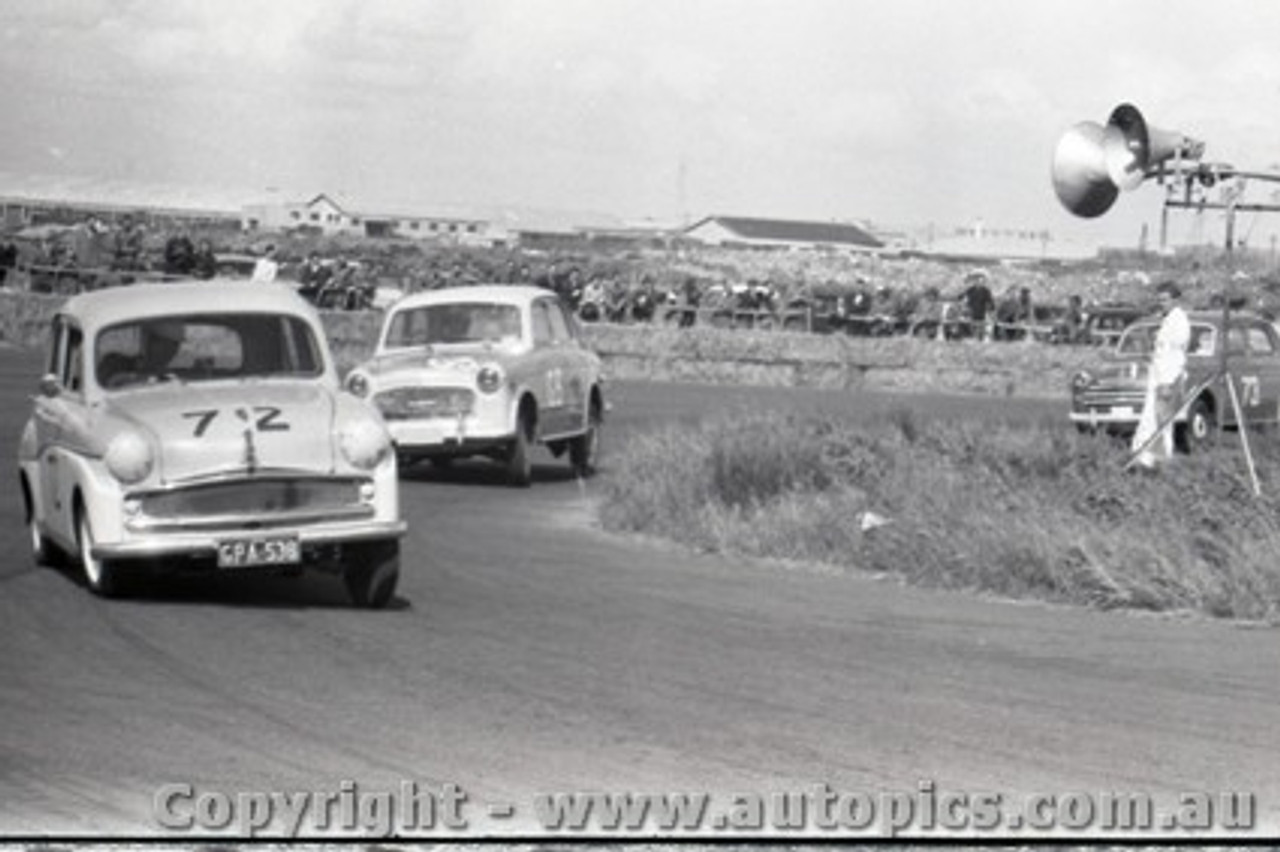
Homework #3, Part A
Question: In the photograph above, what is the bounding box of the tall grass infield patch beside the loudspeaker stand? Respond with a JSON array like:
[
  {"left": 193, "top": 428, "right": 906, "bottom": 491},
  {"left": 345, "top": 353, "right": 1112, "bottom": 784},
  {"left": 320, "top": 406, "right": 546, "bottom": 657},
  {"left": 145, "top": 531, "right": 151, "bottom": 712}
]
[{"left": 602, "top": 411, "right": 1280, "bottom": 618}]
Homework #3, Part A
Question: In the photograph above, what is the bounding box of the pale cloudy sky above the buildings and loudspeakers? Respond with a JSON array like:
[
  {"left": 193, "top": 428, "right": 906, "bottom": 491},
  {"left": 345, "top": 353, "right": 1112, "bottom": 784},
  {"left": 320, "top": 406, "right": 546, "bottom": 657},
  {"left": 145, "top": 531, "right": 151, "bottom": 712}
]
[{"left": 0, "top": 0, "right": 1280, "bottom": 246}]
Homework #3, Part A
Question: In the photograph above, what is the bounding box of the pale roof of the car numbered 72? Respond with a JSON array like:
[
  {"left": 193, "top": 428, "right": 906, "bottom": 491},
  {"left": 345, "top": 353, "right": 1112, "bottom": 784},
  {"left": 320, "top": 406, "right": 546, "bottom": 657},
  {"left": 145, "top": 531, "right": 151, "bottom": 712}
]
[{"left": 60, "top": 278, "right": 319, "bottom": 327}]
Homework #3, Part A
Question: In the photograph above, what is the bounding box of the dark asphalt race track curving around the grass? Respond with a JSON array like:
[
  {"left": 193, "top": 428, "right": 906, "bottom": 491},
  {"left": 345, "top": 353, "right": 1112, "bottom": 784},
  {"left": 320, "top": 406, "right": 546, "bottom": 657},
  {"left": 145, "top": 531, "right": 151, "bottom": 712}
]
[{"left": 0, "top": 352, "right": 1280, "bottom": 837}]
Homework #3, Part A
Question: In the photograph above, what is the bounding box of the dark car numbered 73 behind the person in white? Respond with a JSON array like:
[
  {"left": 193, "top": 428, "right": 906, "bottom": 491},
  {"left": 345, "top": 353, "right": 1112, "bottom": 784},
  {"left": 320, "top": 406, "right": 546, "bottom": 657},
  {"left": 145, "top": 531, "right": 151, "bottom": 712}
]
[{"left": 1070, "top": 310, "right": 1280, "bottom": 450}]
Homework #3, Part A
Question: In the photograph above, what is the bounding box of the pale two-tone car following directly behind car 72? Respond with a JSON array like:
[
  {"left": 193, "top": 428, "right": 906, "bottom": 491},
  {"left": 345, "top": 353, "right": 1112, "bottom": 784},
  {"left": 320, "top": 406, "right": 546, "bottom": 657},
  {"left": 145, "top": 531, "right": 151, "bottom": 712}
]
[{"left": 347, "top": 285, "right": 605, "bottom": 486}]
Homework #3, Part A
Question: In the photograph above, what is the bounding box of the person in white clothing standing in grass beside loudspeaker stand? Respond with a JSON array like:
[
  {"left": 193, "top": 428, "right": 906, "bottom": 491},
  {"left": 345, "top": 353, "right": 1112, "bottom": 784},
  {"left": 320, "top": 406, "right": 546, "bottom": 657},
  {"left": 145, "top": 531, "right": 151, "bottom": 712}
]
[{"left": 1133, "top": 281, "right": 1192, "bottom": 468}]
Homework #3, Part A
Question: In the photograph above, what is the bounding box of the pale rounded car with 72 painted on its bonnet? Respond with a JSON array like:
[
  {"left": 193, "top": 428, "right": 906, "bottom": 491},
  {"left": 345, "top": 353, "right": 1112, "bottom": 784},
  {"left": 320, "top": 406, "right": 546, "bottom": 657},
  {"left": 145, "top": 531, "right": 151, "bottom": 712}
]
[{"left": 18, "top": 279, "right": 404, "bottom": 608}]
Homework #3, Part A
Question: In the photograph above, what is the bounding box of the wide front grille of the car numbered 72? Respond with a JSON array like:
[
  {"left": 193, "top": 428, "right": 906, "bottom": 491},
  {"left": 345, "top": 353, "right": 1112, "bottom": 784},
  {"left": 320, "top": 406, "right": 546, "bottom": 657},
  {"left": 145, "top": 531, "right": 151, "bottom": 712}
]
[{"left": 140, "top": 477, "right": 362, "bottom": 521}]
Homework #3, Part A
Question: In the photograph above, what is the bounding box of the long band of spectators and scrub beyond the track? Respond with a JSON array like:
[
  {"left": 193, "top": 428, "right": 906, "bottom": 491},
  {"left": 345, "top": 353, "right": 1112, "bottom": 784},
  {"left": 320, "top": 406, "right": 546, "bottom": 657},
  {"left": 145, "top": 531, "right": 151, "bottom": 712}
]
[{"left": 0, "top": 215, "right": 1280, "bottom": 340}]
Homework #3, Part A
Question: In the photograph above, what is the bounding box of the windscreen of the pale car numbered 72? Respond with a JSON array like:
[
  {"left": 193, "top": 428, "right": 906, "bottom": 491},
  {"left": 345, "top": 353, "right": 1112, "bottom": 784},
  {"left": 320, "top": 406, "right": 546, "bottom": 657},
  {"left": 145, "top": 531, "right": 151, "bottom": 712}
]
[{"left": 93, "top": 313, "right": 324, "bottom": 389}]
